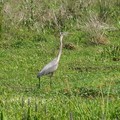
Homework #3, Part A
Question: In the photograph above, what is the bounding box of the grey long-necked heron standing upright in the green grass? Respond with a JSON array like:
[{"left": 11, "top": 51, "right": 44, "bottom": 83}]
[{"left": 37, "top": 32, "right": 67, "bottom": 88}]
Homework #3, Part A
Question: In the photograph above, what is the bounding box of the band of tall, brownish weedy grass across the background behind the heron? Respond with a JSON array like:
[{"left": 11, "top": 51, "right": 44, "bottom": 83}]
[{"left": 0, "top": 0, "right": 119, "bottom": 32}]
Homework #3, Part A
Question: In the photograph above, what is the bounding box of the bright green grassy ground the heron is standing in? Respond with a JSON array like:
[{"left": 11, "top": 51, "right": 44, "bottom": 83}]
[{"left": 0, "top": 31, "right": 120, "bottom": 120}]
